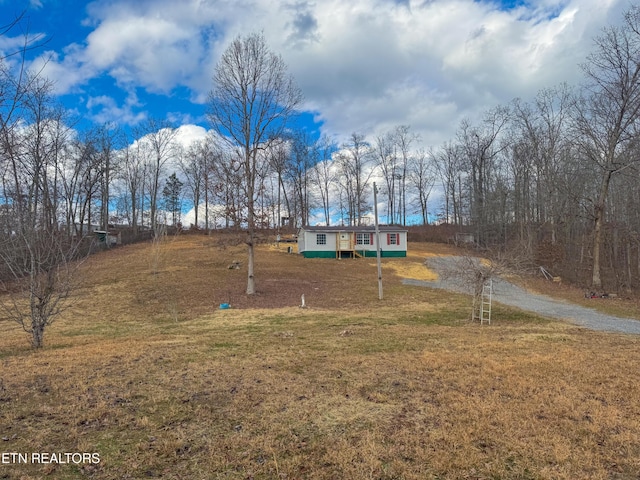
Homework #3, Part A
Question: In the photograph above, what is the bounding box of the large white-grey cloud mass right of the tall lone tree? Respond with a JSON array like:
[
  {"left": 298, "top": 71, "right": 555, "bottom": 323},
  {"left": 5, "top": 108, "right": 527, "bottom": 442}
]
[{"left": 274, "top": 0, "right": 620, "bottom": 142}]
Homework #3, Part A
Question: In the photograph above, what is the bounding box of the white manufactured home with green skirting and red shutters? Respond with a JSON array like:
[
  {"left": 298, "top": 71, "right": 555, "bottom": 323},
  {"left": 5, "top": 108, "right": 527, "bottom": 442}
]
[{"left": 298, "top": 225, "right": 407, "bottom": 258}]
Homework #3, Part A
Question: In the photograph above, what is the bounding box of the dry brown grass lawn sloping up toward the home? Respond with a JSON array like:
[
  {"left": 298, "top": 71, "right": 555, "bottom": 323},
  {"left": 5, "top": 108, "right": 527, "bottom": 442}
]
[{"left": 0, "top": 237, "right": 640, "bottom": 479}]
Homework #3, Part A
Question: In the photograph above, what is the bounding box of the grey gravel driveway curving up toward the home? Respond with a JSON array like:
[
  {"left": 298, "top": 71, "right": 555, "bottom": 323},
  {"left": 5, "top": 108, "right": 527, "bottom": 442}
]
[{"left": 403, "top": 257, "right": 640, "bottom": 335}]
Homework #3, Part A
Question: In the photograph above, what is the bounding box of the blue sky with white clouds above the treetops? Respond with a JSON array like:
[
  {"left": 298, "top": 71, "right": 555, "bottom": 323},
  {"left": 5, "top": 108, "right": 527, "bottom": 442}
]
[{"left": 0, "top": 0, "right": 630, "bottom": 146}]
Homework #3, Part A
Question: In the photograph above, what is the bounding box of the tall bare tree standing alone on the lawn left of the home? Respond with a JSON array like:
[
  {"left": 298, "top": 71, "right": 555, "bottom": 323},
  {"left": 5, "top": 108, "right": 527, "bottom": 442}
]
[{"left": 209, "top": 33, "right": 302, "bottom": 295}]
